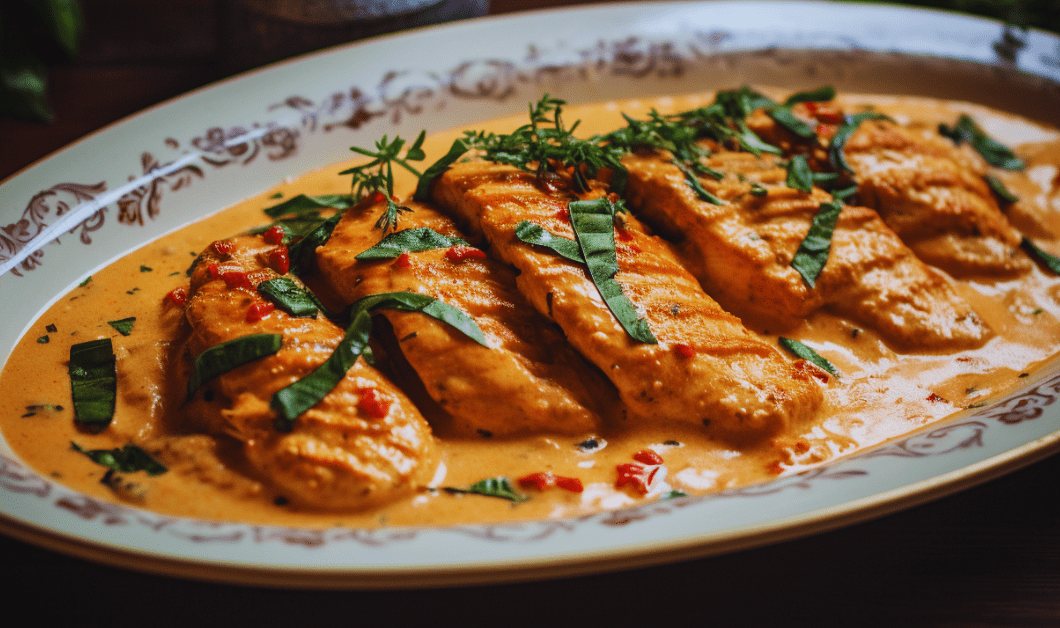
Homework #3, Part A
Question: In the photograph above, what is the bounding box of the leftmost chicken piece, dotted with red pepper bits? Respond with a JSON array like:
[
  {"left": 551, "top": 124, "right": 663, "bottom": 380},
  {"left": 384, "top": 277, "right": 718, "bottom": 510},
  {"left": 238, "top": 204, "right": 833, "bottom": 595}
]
[{"left": 187, "top": 237, "right": 435, "bottom": 510}]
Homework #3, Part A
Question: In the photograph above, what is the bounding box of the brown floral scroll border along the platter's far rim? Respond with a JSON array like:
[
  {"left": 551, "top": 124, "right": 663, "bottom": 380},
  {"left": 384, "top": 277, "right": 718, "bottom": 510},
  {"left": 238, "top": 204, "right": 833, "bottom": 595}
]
[{"left": 0, "top": 32, "right": 729, "bottom": 276}]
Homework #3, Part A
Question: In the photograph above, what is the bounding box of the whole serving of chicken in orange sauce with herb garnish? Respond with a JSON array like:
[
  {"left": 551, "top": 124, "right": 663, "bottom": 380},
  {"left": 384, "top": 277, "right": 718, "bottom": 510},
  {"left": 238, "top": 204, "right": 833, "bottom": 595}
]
[{"left": 0, "top": 88, "right": 1060, "bottom": 527}]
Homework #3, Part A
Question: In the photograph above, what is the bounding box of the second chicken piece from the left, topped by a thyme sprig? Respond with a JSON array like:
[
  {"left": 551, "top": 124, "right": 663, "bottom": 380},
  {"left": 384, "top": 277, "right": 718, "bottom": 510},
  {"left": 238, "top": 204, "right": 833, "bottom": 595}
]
[{"left": 317, "top": 198, "right": 615, "bottom": 436}]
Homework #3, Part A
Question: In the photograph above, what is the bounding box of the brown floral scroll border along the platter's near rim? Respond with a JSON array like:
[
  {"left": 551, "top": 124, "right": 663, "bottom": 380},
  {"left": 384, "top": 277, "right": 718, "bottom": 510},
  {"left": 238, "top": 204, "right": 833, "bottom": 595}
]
[{"left": 0, "top": 373, "right": 1060, "bottom": 547}]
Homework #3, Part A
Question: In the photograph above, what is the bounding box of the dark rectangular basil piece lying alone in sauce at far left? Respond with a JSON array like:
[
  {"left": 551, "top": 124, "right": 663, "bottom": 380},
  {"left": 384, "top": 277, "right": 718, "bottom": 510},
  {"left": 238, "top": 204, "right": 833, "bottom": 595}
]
[{"left": 68, "top": 338, "right": 118, "bottom": 430}]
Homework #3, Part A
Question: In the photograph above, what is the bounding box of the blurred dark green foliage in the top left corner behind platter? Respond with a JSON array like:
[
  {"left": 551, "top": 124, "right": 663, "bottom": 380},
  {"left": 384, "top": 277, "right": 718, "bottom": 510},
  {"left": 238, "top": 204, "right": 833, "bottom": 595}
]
[{"left": 0, "top": 0, "right": 84, "bottom": 122}]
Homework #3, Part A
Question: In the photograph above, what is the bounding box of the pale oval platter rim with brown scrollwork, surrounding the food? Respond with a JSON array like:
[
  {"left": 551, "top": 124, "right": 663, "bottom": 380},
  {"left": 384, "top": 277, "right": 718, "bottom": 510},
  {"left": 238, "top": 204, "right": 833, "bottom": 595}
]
[{"left": 0, "top": 1, "right": 1060, "bottom": 588}]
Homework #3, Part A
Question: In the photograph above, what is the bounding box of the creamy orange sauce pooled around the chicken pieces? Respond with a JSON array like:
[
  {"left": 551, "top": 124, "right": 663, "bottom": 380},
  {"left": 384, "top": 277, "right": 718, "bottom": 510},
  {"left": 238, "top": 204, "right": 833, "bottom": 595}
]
[{"left": 6, "top": 93, "right": 1060, "bottom": 527}]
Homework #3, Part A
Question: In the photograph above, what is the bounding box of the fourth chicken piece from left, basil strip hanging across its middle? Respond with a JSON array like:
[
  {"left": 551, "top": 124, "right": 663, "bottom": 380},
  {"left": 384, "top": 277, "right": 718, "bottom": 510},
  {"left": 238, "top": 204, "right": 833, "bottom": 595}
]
[{"left": 623, "top": 152, "right": 990, "bottom": 349}]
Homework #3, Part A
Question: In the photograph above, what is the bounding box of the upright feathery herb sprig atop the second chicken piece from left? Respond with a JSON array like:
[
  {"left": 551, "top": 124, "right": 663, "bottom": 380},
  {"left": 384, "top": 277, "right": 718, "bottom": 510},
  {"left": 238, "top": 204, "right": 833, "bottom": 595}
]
[{"left": 339, "top": 130, "right": 427, "bottom": 232}]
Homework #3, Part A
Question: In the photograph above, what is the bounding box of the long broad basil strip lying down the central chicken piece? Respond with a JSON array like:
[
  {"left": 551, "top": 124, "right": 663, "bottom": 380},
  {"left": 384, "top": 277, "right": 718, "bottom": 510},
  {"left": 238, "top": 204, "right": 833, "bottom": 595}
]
[{"left": 569, "top": 197, "right": 658, "bottom": 345}]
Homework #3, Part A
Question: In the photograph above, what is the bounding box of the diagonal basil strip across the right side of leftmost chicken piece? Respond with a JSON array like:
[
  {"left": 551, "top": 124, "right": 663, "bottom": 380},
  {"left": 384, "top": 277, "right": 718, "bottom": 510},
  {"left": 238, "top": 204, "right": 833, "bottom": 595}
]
[{"left": 269, "top": 310, "right": 372, "bottom": 432}]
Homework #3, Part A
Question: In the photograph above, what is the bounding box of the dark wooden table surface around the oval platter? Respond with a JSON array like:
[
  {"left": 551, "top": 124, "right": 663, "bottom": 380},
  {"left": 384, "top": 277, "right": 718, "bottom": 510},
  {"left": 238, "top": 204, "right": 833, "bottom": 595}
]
[{"left": 0, "top": 0, "right": 1060, "bottom": 628}]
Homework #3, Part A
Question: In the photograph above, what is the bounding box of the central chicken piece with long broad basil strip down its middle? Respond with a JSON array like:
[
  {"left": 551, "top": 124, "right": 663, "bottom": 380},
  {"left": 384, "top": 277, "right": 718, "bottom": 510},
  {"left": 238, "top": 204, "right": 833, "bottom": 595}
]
[{"left": 431, "top": 160, "right": 823, "bottom": 439}]
